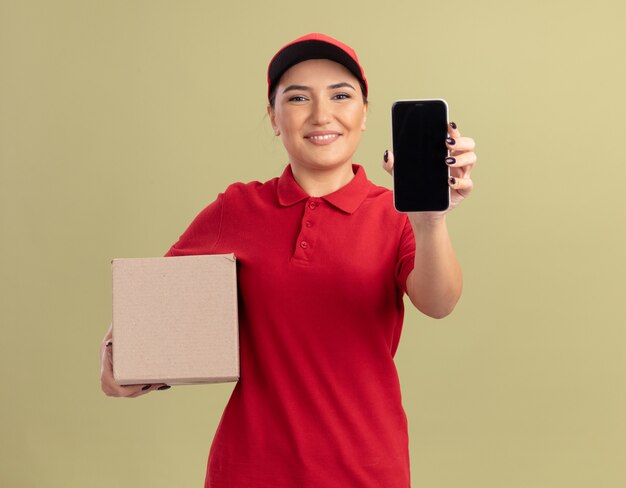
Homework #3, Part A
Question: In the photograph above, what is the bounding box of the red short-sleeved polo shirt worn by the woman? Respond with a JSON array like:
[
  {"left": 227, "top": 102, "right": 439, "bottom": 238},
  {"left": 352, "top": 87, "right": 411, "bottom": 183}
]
[{"left": 167, "top": 165, "right": 415, "bottom": 488}]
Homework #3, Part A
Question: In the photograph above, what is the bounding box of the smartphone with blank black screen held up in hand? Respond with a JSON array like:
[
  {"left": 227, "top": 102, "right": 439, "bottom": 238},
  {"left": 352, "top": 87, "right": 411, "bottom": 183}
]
[{"left": 391, "top": 100, "right": 450, "bottom": 212}]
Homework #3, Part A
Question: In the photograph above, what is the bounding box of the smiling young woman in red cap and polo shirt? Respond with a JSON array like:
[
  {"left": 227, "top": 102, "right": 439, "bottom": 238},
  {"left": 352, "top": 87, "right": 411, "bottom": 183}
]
[{"left": 101, "top": 34, "right": 476, "bottom": 488}]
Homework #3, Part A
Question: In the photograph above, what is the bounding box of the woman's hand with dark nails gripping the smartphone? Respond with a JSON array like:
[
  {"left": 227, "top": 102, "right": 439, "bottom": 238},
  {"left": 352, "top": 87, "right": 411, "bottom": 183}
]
[{"left": 383, "top": 122, "right": 476, "bottom": 214}]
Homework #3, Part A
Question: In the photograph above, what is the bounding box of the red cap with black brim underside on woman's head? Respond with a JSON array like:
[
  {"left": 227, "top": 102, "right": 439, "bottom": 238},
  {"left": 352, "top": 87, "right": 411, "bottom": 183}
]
[{"left": 267, "top": 33, "right": 368, "bottom": 98}]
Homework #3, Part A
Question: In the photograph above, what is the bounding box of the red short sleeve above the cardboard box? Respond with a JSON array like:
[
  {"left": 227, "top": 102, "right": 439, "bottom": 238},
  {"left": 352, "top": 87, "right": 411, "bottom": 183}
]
[{"left": 165, "top": 193, "right": 224, "bottom": 256}]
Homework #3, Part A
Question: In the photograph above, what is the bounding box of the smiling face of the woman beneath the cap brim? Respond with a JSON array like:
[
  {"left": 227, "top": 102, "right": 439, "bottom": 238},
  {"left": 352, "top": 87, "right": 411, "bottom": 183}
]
[{"left": 268, "top": 59, "right": 367, "bottom": 170}]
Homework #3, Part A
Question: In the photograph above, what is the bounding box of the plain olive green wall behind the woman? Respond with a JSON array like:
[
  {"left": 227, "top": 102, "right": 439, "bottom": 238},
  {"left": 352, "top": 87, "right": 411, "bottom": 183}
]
[{"left": 0, "top": 0, "right": 626, "bottom": 488}]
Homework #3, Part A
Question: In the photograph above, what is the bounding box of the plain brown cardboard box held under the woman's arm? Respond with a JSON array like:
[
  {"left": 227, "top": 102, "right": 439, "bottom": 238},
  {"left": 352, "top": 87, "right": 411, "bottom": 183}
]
[{"left": 112, "top": 254, "right": 239, "bottom": 385}]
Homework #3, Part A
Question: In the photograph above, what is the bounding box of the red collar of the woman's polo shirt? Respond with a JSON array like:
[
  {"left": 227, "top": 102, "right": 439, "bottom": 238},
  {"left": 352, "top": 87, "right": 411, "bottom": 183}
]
[{"left": 276, "top": 164, "right": 370, "bottom": 214}]
